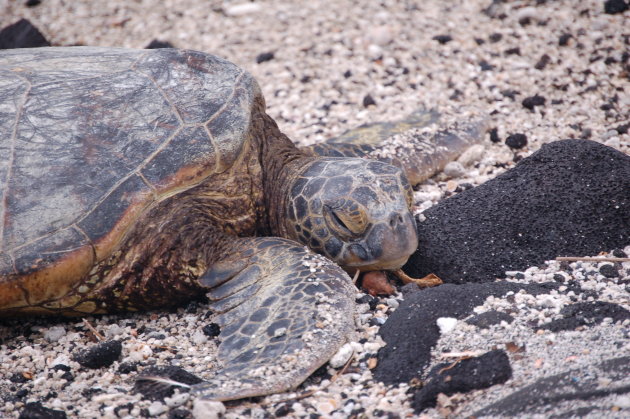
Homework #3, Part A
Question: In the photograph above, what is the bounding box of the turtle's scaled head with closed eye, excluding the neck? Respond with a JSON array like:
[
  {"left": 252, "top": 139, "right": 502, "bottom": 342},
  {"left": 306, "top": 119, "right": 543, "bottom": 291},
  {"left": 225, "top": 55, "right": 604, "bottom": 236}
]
[{"left": 285, "top": 158, "right": 418, "bottom": 273}]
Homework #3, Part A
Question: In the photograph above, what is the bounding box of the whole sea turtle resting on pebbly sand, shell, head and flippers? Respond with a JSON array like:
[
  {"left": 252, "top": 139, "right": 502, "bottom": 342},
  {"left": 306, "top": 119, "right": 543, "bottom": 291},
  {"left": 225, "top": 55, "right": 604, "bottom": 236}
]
[{"left": 0, "top": 47, "right": 486, "bottom": 400}]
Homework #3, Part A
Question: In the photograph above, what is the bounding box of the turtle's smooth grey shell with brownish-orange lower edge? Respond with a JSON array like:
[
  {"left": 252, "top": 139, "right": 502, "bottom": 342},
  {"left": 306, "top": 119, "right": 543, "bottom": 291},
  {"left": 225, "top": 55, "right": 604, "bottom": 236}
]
[{"left": 0, "top": 47, "right": 262, "bottom": 307}]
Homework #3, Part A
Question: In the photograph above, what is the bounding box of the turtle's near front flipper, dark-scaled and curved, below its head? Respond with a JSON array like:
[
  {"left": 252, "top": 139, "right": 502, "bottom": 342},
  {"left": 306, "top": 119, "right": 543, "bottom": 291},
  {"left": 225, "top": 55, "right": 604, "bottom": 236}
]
[{"left": 193, "top": 237, "right": 354, "bottom": 400}]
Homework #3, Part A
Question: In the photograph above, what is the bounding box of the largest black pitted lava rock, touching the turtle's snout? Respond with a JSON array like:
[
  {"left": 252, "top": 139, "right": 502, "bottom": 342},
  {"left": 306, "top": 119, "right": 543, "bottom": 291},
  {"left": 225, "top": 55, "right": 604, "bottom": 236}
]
[{"left": 403, "top": 140, "right": 630, "bottom": 283}]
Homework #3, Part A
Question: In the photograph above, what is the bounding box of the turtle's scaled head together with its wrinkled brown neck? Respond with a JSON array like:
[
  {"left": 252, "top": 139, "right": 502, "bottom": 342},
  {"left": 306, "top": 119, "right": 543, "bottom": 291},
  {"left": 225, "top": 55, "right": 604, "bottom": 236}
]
[{"left": 255, "top": 106, "right": 418, "bottom": 272}]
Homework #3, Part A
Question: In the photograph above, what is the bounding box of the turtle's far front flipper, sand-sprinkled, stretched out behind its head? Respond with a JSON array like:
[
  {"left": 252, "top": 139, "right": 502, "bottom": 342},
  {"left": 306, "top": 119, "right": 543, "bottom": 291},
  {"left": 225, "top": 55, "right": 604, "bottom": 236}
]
[{"left": 302, "top": 108, "right": 487, "bottom": 185}]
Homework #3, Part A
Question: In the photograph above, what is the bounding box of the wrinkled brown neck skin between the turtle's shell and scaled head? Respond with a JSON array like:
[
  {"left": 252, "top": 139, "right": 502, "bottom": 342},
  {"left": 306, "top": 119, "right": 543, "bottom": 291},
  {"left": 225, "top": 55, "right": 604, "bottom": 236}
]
[{"left": 256, "top": 108, "right": 316, "bottom": 239}]
